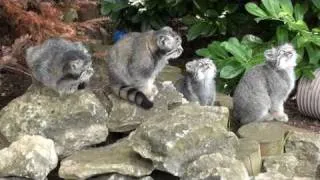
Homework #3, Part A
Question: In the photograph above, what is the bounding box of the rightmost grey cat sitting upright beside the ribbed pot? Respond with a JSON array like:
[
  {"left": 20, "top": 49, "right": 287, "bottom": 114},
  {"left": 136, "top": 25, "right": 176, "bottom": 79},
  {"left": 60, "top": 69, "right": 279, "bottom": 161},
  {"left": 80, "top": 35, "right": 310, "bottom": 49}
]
[{"left": 233, "top": 44, "right": 297, "bottom": 124}]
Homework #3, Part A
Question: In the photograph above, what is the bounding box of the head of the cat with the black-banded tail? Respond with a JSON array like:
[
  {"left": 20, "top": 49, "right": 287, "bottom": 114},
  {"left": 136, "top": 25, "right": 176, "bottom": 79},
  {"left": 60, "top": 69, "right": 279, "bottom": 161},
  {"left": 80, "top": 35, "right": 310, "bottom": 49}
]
[{"left": 156, "top": 26, "right": 183, "bottom": 58}]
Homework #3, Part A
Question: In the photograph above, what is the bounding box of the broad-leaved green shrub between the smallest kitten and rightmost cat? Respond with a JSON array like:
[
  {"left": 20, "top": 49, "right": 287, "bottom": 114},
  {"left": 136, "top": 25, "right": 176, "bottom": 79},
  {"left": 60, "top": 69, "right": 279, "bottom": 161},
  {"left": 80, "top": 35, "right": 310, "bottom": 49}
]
[{"left": 196, "top": 35, "right": 267, "bottom": 94}]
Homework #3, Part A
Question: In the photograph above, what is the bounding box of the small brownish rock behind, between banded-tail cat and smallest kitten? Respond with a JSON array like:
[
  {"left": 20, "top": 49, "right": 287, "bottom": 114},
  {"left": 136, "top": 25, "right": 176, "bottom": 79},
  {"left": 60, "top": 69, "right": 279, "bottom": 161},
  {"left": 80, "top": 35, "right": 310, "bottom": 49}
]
[{"left": 157, "top": 65, "right": 183, "bottom": 84}]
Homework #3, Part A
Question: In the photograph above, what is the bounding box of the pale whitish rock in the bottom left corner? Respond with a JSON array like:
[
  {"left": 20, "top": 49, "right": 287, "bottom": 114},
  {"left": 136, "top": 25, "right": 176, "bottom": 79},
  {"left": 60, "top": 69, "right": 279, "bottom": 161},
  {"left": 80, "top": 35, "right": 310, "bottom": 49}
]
[{"left": 0, "top": 135, "right": 58, "bottom": 180}]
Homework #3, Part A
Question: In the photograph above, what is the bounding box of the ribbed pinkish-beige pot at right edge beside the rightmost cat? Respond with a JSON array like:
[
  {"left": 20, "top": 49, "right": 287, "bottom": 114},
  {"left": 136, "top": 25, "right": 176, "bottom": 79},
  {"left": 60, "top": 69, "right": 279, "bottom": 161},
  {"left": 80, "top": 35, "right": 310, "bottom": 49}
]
[{"left": 297, "top": 69, "right": 320, "bottom": 120}]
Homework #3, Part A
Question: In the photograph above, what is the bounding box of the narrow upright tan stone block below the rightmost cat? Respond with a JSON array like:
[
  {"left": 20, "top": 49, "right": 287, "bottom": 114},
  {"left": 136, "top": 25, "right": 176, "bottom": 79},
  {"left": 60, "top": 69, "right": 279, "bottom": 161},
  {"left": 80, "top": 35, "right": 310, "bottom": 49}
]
[{"left": 237, "top": 138, "right": 262, "bottom": 176}]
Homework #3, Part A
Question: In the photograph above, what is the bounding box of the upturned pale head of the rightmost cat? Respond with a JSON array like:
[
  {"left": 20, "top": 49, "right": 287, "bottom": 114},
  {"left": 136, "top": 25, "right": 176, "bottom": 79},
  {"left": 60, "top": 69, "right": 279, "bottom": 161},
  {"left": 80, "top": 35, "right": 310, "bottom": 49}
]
[{"left": 264, "top": 44, "right": 298, "bottom": 70}]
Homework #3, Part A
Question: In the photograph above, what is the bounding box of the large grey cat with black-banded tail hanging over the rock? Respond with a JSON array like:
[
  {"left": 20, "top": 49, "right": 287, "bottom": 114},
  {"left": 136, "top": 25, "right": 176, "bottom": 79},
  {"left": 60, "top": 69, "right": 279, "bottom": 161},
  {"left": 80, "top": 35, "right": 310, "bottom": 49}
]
[{"left": 106, "top": 27, "right": 183, "bottom": 109}]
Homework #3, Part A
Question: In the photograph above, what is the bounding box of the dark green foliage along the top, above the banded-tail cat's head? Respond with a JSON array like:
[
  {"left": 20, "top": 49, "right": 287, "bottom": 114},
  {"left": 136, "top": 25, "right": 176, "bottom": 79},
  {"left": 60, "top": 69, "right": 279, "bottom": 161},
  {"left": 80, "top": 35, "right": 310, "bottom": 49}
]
[{"left": 101, "top": 0, "right": 247, "bottom": 40}]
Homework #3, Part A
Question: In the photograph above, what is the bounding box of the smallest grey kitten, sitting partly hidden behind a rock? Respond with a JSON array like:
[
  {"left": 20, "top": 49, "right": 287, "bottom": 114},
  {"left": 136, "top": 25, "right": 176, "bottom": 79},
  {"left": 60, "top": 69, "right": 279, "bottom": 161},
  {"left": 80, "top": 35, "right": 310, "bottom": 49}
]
[{"left": 176, "top": 58, "right": 217, "bottom": 105}]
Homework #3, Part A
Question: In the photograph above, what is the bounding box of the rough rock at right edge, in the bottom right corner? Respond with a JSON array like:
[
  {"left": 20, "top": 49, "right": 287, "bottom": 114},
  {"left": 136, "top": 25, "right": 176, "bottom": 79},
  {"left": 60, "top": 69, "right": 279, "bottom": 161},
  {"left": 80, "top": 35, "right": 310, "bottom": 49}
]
[{"left": 285, "top": 132, "right": 320, "bottom": 178}]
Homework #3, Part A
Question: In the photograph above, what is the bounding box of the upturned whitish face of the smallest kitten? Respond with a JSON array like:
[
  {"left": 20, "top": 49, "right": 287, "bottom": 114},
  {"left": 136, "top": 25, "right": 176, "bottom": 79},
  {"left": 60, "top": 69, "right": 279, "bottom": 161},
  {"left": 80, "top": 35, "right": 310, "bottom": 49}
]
[{"left": 186, "top": 58, "right": 217, "bottom": 80}]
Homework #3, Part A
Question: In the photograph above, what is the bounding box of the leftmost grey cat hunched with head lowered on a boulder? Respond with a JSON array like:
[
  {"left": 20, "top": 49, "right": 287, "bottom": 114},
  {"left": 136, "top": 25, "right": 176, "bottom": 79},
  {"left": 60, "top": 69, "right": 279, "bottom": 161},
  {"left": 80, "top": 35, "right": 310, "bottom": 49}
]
[{"left": 26, "top": 38, "right": 94, "bottom": 95}]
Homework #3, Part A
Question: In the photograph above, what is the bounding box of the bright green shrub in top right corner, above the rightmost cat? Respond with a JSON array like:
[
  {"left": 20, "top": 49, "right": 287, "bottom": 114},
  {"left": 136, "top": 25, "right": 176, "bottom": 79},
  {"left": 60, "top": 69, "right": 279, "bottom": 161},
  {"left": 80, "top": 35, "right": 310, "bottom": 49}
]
[{"left": 245, "top": 0, "right": 320, "bottom": 78}]
